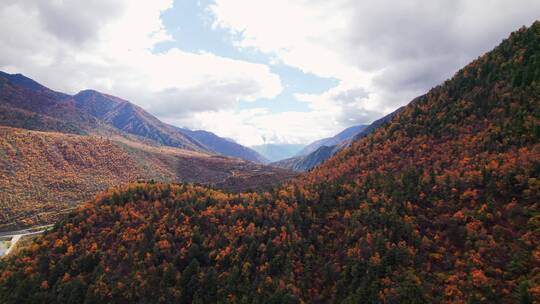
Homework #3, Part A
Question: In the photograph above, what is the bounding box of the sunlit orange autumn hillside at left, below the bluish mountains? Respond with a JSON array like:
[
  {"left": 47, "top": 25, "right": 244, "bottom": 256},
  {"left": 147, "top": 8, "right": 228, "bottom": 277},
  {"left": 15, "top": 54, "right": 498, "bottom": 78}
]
[{"left": 0, "top": 127, "right": 142, "bottom": 229}]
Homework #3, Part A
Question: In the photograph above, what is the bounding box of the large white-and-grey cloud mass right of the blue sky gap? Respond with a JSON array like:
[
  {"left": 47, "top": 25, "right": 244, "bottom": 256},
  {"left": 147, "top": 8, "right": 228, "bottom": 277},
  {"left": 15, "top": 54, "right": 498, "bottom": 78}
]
[{"left": 210, "top": 0, "right": 540, "bottom": 137}]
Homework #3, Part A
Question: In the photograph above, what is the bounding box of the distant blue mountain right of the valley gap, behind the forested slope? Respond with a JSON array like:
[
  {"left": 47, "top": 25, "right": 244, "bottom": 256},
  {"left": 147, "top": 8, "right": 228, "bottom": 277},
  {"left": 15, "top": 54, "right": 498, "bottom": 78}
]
[{"left": 276, "top": 108, "right": 401, "bottom": 172}]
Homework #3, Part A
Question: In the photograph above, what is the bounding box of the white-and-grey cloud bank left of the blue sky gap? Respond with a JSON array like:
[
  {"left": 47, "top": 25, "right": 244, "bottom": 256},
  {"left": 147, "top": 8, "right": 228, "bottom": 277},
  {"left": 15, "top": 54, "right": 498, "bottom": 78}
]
[{"left": 0, "top": 0, "right": 282, "bottom": 123}]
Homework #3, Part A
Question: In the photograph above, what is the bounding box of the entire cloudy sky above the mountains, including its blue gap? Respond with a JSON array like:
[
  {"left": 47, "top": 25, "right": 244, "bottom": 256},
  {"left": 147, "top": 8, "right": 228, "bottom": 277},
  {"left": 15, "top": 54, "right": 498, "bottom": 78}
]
[{"left": 0, "top": 0, "right": 540, "bottom": 145}]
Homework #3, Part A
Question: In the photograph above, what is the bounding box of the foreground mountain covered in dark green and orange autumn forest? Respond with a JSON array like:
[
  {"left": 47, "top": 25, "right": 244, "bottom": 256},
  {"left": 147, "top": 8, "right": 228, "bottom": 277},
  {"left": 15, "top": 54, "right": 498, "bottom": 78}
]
[{"left": 0, "top": 22, "right": 540, "bottom": 303}]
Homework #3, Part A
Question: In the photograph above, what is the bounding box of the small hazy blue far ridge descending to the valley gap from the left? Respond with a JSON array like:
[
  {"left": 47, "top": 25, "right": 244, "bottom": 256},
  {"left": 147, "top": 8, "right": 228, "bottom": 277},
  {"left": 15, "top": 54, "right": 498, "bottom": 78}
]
[{"left": 179, "top": 128, "right": 268, "bottom": 164}]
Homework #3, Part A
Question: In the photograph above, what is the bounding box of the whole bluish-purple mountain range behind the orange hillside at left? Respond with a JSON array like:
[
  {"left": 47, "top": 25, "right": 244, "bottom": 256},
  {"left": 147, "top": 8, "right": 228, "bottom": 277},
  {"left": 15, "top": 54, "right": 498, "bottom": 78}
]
[{"left": 0, "top": 72, "right": 267, "bottom": 163}]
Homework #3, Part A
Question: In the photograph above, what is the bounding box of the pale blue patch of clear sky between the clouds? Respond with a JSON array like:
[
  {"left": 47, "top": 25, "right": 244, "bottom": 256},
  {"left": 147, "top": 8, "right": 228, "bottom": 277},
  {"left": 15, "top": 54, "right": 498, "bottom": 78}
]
[{"left": 153, "top": 0, "right": 338, "bottom": 113}]
